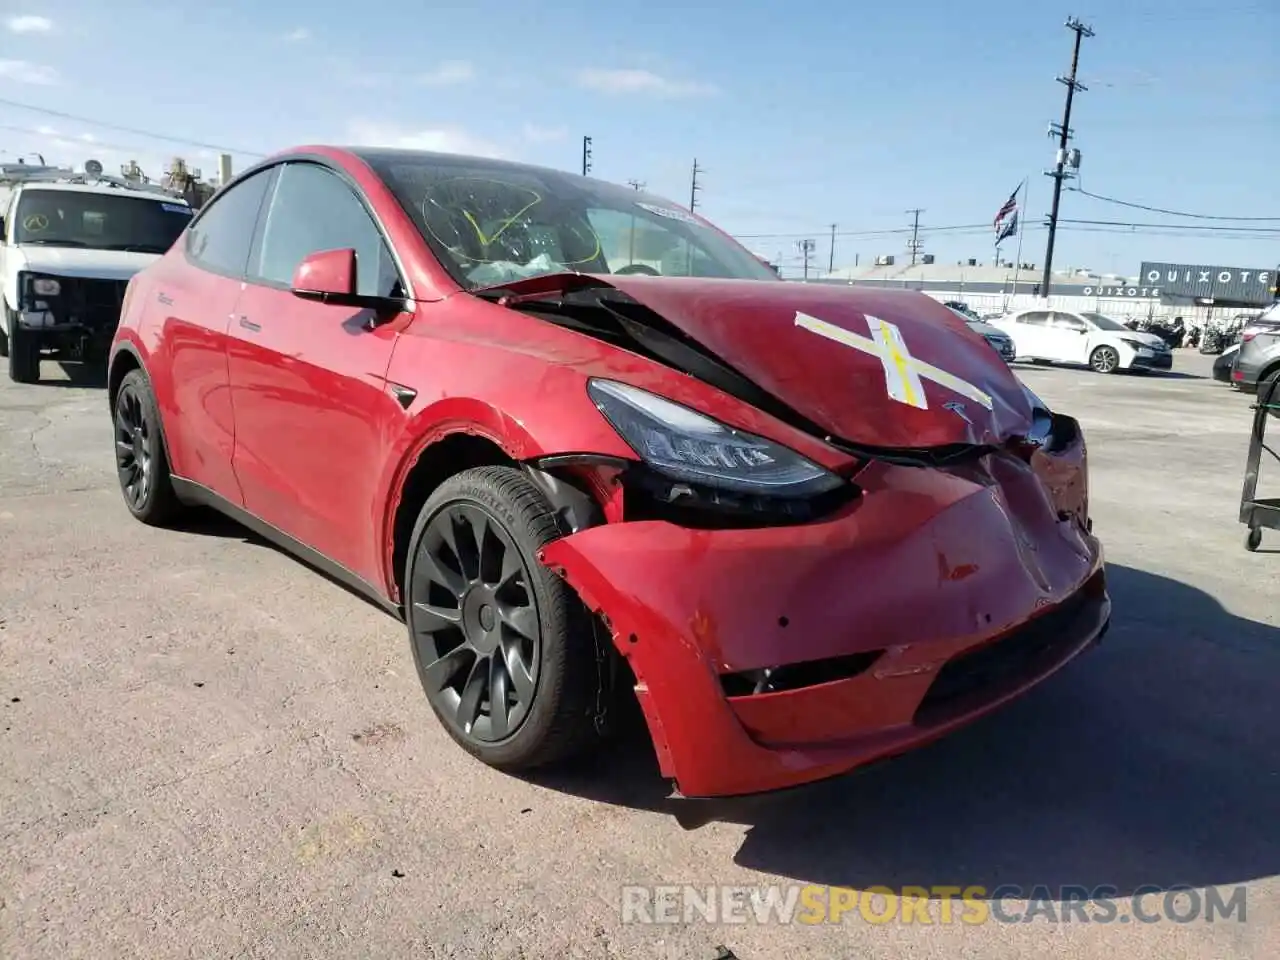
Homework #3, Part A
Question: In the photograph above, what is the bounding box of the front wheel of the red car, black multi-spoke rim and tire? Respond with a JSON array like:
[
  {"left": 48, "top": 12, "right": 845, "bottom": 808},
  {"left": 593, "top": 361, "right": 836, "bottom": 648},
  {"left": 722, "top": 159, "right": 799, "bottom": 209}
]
[{"left": 404, "top": 467, "right": 600, "bottom": 772}]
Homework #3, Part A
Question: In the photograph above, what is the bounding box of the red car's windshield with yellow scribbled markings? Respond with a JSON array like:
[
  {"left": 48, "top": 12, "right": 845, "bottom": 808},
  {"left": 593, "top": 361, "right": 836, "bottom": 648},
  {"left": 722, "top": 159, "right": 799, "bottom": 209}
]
[{"left": 362, "top": 151, "right": 778, "bottom": 289}]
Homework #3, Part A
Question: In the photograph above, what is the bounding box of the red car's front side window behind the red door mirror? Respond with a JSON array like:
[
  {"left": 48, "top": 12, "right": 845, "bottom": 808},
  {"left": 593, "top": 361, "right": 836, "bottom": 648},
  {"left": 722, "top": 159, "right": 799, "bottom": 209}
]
[{"left": 250, "top": 163, "right": 401, "bottom": 297}]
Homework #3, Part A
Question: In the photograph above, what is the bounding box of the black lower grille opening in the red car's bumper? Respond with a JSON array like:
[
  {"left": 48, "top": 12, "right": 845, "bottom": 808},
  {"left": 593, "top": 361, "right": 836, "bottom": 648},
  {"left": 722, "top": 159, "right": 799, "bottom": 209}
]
[{"left": 914, "top": 573, "right": 1102, "bottom": 727}]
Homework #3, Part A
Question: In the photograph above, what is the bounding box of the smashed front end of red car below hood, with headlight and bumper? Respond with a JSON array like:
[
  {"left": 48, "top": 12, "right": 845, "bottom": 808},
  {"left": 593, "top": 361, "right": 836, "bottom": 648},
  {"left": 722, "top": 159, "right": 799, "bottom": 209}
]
[{"left": 483, "top": 278, "right": 1110, "bottom": 797}]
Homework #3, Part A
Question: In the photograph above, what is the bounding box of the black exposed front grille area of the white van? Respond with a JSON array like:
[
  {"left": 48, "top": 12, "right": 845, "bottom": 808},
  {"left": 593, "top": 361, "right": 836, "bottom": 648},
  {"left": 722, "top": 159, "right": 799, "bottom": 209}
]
[{"left": 13, "top": 271, "right": 128, "bottom": 361}]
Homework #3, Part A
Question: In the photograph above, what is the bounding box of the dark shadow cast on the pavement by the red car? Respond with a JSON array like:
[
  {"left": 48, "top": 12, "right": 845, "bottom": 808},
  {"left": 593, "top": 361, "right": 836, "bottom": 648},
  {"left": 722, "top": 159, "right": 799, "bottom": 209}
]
[{"left": 536, "top": 564, "right": 1280, "bottom": 899}]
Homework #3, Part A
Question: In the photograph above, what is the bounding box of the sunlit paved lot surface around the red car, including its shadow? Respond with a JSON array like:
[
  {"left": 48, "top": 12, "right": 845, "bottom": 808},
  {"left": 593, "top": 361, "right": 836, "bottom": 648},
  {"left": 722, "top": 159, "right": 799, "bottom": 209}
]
[{"left": 0, "top": 351, "right": 1280, "bottom": 960}]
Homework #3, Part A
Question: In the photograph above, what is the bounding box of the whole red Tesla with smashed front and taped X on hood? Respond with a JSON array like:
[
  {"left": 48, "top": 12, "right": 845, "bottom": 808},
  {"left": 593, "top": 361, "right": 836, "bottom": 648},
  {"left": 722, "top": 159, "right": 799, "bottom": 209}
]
[{"left": 109, "top": 147, "right": 1111, "bottom": 797}]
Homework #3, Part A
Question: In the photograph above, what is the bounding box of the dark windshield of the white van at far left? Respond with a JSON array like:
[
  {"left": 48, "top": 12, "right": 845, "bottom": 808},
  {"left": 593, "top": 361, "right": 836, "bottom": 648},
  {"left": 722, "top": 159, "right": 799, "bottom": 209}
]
[{"left": 13, "top": 188, "right": 191, "bottom": 253}]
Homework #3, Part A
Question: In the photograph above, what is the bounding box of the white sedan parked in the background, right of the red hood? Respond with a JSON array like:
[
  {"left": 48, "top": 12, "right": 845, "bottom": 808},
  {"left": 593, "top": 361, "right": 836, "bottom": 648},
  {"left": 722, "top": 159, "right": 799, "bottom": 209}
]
[{"left": 987, "top": 310, "right": 1174, "bottom": 374}]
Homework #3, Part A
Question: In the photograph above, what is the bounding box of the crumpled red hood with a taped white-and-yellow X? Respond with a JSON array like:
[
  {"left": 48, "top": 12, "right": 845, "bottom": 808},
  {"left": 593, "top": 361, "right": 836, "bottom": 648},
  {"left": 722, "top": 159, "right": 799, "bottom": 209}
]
[{"left": 504, "top": 275, "right": 1032, "bottom": 448}]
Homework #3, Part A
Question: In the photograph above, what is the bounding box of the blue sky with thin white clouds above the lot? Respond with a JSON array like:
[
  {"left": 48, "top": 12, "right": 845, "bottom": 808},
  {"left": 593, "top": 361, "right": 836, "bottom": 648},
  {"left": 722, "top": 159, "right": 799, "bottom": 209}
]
[{"left": 0, "top": 0, "right": 1280, "bottom": 274}]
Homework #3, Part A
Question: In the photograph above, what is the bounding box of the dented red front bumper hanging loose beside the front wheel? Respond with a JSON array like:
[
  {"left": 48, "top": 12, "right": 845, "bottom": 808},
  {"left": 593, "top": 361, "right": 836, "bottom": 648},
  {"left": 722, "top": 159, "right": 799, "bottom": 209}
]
[{"left": 543, "top": 444, "right": 1111, "bottom": 797}]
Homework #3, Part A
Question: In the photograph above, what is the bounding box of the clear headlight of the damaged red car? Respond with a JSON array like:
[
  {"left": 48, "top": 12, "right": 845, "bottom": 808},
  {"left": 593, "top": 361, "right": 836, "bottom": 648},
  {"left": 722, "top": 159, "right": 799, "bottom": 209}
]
[{"left": 586, "top": 380, "right": 845, "bottom": 498}]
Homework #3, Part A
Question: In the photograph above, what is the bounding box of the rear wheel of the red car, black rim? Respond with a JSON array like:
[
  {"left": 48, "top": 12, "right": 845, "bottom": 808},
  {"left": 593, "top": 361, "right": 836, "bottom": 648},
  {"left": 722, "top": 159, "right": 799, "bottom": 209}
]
[{"left": 111, "top": 370, "right": 183, "bottom": 526}]
